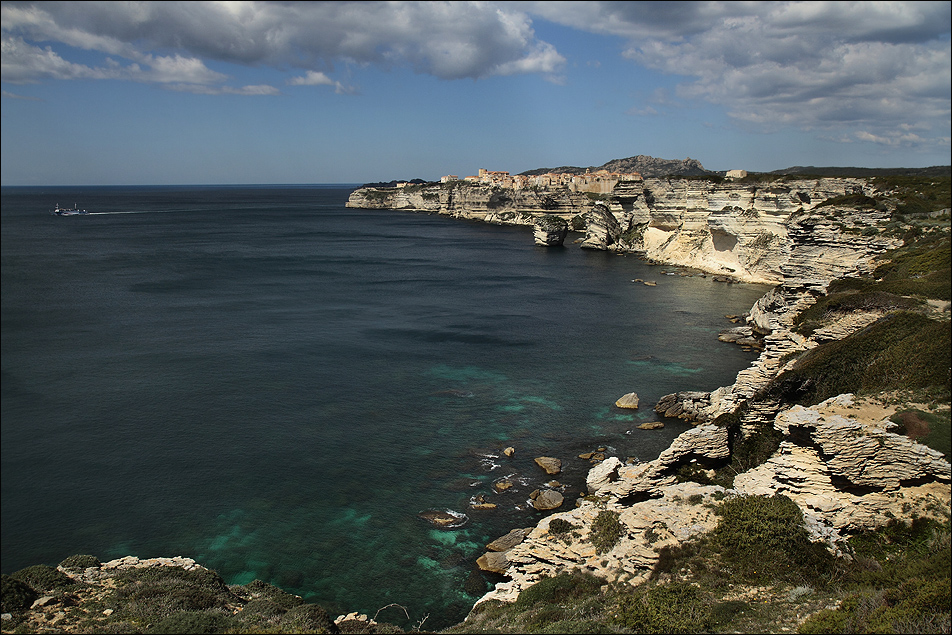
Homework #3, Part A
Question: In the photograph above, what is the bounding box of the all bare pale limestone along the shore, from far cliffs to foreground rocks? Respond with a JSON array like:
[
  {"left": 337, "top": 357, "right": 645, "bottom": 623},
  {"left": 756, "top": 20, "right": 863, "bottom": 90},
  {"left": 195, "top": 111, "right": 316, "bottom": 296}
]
[{"left": 4, "top": 179, "right": 952, "bottom": 632}]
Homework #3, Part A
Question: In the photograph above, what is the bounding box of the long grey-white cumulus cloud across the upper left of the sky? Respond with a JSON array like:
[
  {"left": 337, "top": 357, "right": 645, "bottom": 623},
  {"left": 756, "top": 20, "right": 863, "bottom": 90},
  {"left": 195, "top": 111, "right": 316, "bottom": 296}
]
[{"left": 2, "top": 1, "right": 565, "bottom": 93}]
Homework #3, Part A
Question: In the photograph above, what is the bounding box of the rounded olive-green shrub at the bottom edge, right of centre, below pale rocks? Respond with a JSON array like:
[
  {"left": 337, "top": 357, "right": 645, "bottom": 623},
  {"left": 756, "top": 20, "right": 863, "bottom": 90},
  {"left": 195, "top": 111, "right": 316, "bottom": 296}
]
[{"left": 615, "top": 582, "right": 712, "bottom": 633}]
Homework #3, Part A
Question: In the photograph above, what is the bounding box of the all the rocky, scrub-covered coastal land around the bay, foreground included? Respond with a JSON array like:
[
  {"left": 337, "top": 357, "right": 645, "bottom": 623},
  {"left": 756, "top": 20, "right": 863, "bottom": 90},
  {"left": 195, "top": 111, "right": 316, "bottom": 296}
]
[{"left": 3, "top": 160, "right": 952, "bottom": 632}]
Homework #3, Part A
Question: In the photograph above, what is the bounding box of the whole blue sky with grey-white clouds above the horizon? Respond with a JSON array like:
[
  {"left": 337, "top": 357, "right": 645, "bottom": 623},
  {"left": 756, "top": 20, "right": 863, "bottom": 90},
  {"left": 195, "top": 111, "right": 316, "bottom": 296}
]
[{"left": 0, "top": 0, "right": 952, "bottom": 186}]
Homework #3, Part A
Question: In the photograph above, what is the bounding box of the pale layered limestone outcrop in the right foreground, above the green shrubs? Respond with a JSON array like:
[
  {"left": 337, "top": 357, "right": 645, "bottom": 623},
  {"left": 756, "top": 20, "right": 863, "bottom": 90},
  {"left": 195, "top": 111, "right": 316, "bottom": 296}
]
[{"left": 480, "top": 395, "right": 952, "bottom": 602}]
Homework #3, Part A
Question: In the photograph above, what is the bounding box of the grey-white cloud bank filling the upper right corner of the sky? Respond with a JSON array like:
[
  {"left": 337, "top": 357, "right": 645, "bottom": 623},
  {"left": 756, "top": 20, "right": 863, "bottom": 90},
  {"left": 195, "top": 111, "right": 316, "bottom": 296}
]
[{"left": 522, "top": 2, "right": 952, "bottom": 146}]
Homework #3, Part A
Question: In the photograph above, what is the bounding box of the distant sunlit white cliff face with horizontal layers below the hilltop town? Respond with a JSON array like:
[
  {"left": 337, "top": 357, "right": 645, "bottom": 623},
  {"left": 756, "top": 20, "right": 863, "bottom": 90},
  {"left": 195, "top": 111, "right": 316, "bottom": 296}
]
[{"left": 347, "top": 178, "right": 896, "bottom": 290}]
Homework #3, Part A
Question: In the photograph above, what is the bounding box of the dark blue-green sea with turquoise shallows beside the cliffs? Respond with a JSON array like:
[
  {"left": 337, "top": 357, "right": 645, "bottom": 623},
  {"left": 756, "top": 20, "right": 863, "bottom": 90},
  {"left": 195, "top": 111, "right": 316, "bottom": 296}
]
[{"left": 0, "top": 185, "right": 767, "bottom": 629}]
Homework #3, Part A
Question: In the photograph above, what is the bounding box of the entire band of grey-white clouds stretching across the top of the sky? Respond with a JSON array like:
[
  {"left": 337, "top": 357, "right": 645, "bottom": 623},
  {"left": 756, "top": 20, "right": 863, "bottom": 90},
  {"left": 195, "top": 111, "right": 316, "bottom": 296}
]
[{"left": 2, "top": 1, "right": 952, "bottom": 146}]
